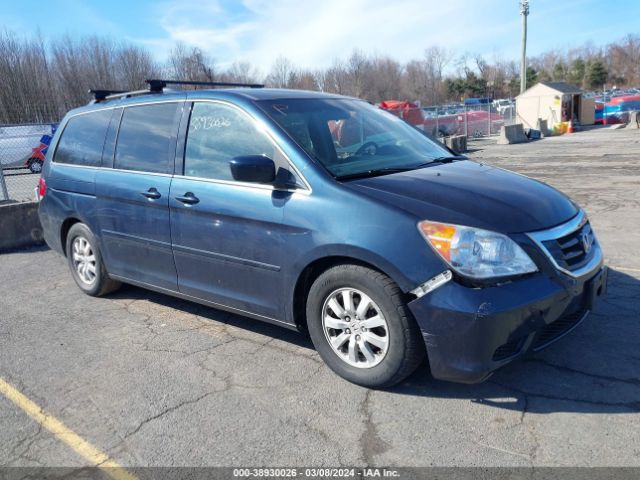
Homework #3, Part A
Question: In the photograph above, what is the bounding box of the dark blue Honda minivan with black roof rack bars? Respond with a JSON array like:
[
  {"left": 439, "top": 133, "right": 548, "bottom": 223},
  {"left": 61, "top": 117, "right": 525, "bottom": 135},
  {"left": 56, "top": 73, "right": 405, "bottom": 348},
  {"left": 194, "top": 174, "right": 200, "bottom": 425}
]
[{"left": 39, "top": 81, "right": 607, "bottom": 387}]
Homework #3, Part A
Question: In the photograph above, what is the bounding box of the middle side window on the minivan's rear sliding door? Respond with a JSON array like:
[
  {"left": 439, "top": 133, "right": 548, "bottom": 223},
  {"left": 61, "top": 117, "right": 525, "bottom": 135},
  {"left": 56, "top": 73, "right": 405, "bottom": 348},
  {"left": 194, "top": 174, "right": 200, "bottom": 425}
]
[{"left": 114, "top": 103, "right": 178, "bottom": 173}]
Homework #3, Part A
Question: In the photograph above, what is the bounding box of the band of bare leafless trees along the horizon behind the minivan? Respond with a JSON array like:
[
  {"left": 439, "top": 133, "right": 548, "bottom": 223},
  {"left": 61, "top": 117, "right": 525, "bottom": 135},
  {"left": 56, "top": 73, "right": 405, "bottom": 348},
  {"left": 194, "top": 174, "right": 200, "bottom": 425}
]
[{"left": 0, "top": 31, "right": 640, "bottom": 123}]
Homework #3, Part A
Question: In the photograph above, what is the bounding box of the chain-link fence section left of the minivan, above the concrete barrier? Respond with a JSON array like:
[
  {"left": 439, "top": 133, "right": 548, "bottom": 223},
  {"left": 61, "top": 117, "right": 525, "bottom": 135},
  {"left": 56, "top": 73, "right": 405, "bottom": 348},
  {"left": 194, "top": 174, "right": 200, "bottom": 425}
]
[{"left": 0, "top": 123, "right": 57, "bottom": 202}]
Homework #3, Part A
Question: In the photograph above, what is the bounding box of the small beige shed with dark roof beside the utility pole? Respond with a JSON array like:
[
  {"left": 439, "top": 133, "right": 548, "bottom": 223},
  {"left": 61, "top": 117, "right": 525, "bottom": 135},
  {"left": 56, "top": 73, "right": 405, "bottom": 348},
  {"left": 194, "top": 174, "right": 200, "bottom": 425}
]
[{"left": 516, "top": 82, "right": 595, "bottom": 128}]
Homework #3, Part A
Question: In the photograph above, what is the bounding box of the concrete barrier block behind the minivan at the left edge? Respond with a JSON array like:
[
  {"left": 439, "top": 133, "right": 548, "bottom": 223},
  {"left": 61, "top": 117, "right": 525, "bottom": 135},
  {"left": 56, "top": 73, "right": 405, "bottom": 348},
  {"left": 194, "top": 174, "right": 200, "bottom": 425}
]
[{"left": 0, "top": 202, "right": 44, "bottom": 252}]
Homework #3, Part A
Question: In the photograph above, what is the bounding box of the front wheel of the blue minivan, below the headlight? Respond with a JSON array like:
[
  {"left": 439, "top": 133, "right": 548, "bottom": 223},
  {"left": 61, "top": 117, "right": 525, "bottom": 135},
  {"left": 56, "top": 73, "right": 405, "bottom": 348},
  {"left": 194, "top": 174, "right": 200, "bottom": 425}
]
[{"left": 306, "top": 264, "right": 426, "bottom": 388}]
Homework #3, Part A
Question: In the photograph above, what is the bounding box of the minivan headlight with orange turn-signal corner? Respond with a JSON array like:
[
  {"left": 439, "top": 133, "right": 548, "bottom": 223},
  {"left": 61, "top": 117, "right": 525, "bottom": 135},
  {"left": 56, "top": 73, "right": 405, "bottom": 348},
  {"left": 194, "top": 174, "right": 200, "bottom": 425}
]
[{"left": 418, "top": 221, "right": 538, "bottom": 279}]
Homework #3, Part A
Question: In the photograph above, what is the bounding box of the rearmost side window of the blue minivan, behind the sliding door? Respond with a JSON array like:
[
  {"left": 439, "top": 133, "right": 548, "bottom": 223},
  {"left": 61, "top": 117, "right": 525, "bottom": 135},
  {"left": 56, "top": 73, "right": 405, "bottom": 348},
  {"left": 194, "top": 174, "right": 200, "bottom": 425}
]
[{"left": 54, "top": 110, "right": 113, "bottom": 167}]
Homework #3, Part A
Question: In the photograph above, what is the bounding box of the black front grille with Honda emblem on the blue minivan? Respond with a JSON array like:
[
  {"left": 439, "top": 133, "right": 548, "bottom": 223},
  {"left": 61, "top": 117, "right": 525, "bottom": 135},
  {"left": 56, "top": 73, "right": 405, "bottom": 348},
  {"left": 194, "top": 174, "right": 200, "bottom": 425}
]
[{"left": 542, "top": 222, "right": 596, "bottom": 271}]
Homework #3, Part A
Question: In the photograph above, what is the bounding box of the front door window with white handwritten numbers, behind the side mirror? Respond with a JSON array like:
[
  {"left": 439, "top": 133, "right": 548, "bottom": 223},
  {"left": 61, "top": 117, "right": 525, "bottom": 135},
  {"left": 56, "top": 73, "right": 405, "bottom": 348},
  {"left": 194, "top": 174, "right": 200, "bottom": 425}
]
[{"left": 184, "top": 103, "right": 277, "bottom": 180}]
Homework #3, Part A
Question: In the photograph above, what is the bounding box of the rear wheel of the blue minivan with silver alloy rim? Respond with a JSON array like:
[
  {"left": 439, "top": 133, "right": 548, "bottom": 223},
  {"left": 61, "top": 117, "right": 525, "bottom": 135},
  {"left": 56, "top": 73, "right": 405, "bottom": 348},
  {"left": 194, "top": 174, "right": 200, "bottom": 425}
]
[{"left": 66, "top": 223, "right": 121, "bottom": 297}]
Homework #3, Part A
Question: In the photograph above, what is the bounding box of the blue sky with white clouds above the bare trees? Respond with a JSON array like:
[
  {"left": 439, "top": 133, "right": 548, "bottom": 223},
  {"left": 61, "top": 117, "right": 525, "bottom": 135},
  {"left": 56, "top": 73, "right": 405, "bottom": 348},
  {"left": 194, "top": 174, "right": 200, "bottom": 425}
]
[{"left": 0, "top": 0, "right": 640, "bottom": 73}]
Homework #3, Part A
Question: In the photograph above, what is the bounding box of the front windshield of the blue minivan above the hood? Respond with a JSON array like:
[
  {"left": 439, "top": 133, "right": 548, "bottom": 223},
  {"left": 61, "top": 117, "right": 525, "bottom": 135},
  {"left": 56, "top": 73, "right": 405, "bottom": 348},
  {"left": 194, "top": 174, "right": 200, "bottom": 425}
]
[{"left": 258, "top": 98, "right": 452, "bottom": 178}]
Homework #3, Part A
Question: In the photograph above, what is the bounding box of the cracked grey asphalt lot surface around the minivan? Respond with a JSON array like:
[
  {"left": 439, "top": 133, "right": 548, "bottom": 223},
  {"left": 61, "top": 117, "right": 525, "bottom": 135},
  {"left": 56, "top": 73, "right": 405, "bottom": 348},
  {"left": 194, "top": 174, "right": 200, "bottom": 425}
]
[{"left": 0, "top": 129, "right": 640, "bottom": 467}]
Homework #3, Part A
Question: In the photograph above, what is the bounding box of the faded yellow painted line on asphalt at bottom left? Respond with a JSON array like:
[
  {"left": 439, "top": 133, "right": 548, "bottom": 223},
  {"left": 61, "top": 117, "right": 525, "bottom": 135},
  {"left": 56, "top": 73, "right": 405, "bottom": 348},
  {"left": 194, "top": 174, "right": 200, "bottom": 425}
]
[{"left": 0, "top": 377, "right": 137, "bottom": 480}]
